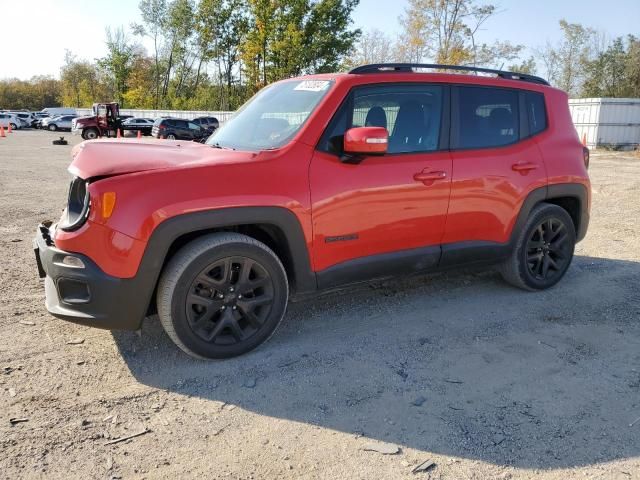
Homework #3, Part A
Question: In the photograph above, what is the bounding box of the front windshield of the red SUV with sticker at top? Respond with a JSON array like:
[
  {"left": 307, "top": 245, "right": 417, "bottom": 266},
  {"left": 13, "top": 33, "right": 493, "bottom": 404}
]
[{"left": 207, "top": 80, "right": 333, "bottom": 150}]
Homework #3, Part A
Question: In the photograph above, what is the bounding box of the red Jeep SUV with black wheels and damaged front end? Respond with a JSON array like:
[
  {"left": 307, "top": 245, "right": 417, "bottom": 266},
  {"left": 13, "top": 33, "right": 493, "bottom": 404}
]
[{"left": 35, "top": 64, "right": 591, "bottom": 358}]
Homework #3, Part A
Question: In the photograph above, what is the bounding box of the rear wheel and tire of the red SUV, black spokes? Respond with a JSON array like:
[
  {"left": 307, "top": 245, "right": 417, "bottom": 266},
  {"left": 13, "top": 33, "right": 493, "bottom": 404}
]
[{"left": 500, "top": 203, "right": 576, "bottom": 291}]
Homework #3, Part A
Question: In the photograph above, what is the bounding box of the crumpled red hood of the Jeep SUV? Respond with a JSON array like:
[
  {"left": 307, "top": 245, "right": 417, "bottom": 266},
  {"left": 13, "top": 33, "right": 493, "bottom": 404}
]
[{"left": 69, "top": 139, "right": 257, "bottom": 179}]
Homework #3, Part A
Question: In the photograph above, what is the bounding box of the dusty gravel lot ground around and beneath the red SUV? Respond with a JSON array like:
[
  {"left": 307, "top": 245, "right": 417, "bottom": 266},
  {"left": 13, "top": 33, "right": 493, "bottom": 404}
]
[{"left": 0, "top": 131, "right": 640, "bottom": 480}]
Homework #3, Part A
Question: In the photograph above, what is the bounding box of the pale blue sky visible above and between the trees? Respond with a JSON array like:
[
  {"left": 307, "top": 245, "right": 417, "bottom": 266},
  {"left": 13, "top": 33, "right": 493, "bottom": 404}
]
[{"left": 0, "top": 0, "right": 640, "bottom": 79}]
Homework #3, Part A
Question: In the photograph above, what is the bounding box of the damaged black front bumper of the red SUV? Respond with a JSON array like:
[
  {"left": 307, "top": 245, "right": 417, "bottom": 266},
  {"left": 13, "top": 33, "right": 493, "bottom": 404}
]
[{"left": 33, "top": 224, "right": 148, "bottom": 330}]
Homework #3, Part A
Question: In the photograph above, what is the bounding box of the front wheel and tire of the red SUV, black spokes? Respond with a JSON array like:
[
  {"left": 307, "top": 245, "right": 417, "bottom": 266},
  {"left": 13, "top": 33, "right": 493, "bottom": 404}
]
[{"left": 157, "top": 232, "right": 289, "bottom": 359}]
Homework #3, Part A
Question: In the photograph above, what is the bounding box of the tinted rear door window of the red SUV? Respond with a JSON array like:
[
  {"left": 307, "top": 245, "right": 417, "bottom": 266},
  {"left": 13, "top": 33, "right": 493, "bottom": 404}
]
[{"left": 452, "top": 86, "right": 520, "bottom": 149}]
